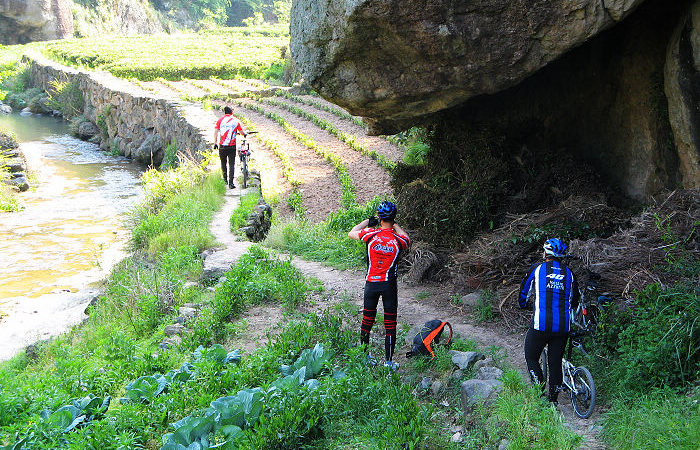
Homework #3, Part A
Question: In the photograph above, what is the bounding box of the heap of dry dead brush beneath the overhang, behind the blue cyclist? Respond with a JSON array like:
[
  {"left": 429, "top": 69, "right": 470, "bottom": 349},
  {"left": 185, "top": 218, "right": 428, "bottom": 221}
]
[{"left": 451, "top": 189, "right": 700, "bottom": 326}]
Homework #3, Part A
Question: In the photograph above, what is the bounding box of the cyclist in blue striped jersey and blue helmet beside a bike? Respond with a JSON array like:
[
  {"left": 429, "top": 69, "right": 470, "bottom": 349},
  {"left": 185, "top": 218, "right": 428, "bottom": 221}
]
[{"left": 519, "top": 238, "right": 580, "bottom": 404}]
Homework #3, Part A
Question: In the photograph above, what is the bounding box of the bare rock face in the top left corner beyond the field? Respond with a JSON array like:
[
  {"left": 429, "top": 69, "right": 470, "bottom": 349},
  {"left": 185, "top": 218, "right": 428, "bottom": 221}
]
[{"left": 0, "top": 0, "right": 73, "bottom": 45}]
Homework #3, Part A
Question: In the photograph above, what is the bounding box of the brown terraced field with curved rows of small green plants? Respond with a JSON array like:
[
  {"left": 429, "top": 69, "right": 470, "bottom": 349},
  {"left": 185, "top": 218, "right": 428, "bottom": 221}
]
[{"left": 133, "top": 78, "right": 403, "bottom": 221}]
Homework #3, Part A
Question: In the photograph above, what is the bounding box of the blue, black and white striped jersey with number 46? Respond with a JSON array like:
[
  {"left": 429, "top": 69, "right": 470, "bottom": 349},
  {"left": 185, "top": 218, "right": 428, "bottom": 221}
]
[{"left": 520, "top": 260, "right": 580, "bottom": 333}]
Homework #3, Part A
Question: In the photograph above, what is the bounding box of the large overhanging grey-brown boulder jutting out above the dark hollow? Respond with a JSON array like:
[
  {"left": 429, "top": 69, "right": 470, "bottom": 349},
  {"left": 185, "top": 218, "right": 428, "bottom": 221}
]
[{"left": 291, "top": 0, "right": 643, "bottom": 132}]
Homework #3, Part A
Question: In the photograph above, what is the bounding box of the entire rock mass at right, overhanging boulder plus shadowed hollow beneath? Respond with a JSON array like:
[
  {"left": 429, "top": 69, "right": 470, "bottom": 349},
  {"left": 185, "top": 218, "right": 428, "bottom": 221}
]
[{"left": 292, "top": 0, "right": 700, "bottom": 200}]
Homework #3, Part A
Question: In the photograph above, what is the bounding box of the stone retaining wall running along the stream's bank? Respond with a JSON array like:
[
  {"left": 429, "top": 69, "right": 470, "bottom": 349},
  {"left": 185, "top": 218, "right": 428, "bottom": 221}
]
[{"left": 24, "top": 54, "right": 215, "bottom": 165}]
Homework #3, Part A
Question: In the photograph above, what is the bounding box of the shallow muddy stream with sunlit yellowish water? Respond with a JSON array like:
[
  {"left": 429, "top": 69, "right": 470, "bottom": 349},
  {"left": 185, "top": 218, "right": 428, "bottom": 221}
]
[{"left": 0, "top": 115, "right": 143, "bottom": 360}]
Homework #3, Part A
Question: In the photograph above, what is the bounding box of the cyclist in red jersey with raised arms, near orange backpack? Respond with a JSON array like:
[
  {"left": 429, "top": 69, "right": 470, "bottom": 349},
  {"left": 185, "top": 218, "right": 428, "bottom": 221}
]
[{"left": 348, "top": 202, "right": 411, "bottom": 370}]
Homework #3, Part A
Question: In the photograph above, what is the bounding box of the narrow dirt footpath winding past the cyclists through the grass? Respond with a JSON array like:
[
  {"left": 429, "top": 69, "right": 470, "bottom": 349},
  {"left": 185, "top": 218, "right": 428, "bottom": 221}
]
[{"left": 204, "top": 184, "right": 607, "bottom": 449}]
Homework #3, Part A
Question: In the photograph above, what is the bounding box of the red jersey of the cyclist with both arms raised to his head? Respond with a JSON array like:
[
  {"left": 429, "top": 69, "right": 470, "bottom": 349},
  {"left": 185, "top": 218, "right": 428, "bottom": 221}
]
[{"left": 360, "top": 228, "right": 411, "bottom": 282}]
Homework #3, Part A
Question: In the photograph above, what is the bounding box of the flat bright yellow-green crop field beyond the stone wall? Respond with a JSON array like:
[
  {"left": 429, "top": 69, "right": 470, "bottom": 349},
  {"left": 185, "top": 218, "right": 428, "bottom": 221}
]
[{"left": 39, "top": 28, "right": 289, "bottom": 81}]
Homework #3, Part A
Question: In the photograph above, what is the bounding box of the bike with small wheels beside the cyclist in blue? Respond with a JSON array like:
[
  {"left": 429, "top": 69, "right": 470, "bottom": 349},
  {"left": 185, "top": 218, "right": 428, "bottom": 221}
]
[{"left": 540, "top": 333, "right": 595, "bottom": 419}]
